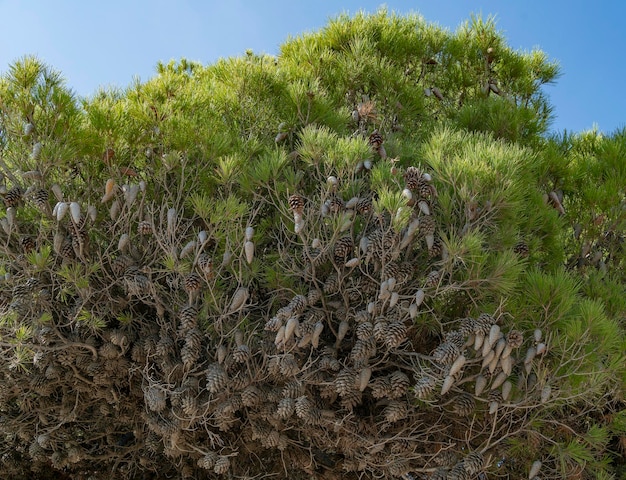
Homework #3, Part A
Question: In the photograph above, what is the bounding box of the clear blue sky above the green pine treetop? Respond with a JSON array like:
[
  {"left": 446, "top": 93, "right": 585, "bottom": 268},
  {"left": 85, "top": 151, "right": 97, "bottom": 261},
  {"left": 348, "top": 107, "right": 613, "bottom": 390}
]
[{"left": 0, "top": 0, "right": 626, "bottom": 133}]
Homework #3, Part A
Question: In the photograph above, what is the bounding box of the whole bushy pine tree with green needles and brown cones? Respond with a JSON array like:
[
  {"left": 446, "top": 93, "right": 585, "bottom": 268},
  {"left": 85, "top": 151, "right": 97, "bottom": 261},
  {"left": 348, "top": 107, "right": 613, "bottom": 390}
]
[{"left": 0, "top": 11, "right": 626, "bottom": 480}]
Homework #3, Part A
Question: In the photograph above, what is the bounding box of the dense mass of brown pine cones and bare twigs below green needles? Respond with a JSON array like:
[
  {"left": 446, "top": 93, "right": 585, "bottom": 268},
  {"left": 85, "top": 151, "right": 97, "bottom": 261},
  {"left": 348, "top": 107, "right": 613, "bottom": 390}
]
[{"left": 0, "top": 128, "right": 550, "bottom": 479}]
